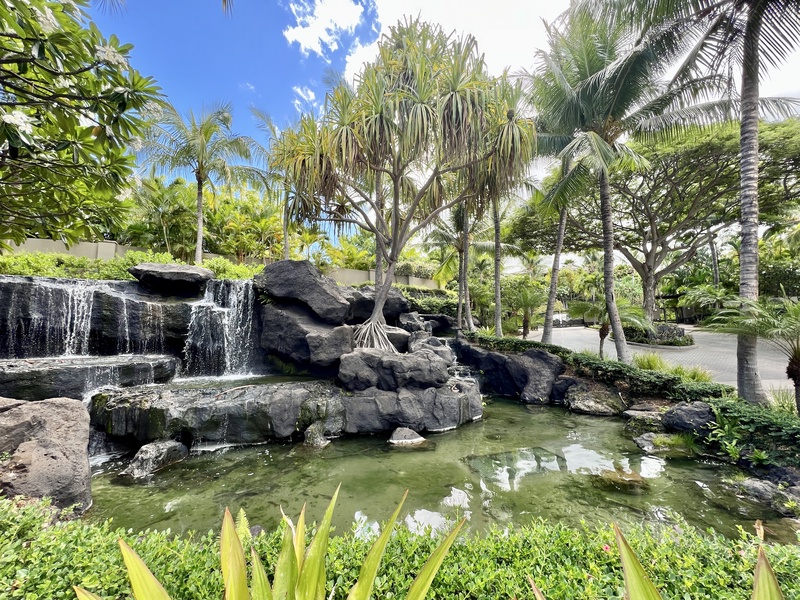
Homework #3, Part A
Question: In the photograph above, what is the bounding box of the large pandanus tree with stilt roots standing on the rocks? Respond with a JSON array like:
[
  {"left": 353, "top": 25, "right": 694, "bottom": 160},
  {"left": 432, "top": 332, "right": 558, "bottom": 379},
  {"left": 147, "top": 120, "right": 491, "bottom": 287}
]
[{"left": 273, "top": 19, "right": 535, "bottom": 351}]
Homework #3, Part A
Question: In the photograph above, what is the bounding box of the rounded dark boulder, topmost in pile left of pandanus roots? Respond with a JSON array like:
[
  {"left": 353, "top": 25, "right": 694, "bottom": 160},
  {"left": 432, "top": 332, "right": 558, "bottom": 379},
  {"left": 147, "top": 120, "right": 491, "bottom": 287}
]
[{"left": 254, "top": 260, "right": 350, "bottom": 325}]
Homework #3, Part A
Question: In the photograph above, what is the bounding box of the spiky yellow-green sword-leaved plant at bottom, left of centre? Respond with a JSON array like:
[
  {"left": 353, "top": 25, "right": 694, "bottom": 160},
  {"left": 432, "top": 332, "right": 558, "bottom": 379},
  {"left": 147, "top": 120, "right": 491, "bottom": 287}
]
[{"left": 74, "top": 488, "right": 466, "bottom": 600}]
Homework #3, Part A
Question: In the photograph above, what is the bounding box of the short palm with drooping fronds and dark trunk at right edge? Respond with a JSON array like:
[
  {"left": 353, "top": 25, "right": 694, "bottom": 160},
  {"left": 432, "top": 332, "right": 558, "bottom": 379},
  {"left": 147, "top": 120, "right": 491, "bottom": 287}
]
[{"left": 706, "top": 295, "right": 800, "bottom": 415}]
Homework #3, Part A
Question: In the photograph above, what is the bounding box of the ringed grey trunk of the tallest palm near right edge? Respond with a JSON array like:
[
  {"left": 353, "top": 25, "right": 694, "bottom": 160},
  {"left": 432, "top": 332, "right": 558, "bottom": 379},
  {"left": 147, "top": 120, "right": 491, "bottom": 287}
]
[{"left": 736, "top": 2, "right": 768, "bottom": 404}]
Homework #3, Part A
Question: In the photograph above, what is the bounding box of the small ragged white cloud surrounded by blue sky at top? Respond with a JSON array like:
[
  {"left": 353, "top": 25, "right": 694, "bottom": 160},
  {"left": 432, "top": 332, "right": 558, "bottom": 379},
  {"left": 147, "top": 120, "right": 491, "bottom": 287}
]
[{"left": 283, "top": 0, "right": 364, "bottom": 60}]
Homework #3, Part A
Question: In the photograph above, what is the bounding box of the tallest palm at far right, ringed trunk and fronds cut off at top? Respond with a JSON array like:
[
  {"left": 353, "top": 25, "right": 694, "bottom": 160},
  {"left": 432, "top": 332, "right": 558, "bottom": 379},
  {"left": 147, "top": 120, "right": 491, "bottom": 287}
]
[{"left": 595, "top": 0, "right": 800, "bottom": 403}]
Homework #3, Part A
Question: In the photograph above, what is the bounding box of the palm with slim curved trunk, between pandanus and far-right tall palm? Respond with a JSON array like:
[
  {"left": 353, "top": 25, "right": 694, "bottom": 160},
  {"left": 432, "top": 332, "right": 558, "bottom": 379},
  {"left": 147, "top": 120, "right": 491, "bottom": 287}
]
[{"left": 532, "top": 9, "right": 726, "bottom": 363}]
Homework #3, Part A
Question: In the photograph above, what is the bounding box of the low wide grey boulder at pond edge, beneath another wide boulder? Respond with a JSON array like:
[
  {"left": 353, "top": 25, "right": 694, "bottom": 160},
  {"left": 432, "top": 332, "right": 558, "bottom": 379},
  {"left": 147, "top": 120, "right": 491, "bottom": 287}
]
[{"left": 342, "top": 379, "right": 483, "bottom": 433}]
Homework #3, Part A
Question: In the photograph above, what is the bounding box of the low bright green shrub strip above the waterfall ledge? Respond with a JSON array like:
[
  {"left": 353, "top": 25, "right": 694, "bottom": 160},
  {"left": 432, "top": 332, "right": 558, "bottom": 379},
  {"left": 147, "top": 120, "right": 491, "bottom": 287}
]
[{"left": 0, "top": 250, "right": 264, "bottom": 280}]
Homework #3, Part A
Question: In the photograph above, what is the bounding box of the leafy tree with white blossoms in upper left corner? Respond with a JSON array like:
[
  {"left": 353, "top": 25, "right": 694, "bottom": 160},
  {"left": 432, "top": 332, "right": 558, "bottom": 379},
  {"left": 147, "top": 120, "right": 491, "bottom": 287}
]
[{"left": 0, "top": 0, "right": 158, "bottom": 245}]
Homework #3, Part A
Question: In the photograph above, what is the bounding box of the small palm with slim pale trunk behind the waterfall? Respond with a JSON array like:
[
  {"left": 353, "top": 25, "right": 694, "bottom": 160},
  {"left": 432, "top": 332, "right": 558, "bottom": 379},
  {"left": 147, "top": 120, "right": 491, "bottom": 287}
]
[{"left": 142, "top": 104, "right": 252, "bottom": 265}]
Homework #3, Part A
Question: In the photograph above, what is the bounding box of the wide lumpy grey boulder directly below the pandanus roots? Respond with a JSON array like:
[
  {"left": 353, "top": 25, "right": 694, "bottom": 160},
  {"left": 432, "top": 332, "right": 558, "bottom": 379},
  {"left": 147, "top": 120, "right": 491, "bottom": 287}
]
[{"left": 339, "top": 348, "right": 450, "bottom": 392}]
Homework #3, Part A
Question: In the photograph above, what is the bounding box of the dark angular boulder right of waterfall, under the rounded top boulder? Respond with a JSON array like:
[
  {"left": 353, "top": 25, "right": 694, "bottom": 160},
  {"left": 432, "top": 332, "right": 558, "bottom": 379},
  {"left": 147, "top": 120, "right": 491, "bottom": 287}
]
[{"left": 260, "top": 304, "right": 353, "bottom": 375}]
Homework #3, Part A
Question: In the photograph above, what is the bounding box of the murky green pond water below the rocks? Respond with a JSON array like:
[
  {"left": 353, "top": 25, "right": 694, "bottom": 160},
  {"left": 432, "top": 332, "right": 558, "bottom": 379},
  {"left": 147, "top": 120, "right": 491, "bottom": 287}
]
[{"left": 88, "top": 400, "right": 797, "bottom": 542}]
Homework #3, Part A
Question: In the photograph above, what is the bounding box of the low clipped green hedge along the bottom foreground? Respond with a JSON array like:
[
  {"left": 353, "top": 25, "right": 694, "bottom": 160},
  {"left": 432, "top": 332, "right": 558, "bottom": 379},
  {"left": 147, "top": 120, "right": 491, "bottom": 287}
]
[{"left": 0, "top": 496, "right": 800, "bottom": 600}]
